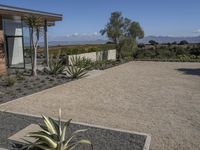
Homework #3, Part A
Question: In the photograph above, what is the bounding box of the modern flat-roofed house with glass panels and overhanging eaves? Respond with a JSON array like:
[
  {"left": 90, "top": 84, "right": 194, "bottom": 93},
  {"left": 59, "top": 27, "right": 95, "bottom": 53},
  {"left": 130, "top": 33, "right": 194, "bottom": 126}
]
[{"left": 0, "top": 4, "right": 62, "bottom": 74}]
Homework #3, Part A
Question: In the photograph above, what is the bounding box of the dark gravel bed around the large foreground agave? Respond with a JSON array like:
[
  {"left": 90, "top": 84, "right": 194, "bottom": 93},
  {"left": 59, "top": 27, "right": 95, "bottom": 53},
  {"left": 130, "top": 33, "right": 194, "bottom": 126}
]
[{"left": 0, "top": 112, "right": 146, "bottom": 150}]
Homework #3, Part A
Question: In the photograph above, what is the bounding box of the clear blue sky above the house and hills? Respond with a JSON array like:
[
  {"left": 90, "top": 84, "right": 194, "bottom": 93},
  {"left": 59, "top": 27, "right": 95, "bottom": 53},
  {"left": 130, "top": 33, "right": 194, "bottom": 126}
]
[{"left": 0, "top": 0, "right": 200, "bottom": 38}]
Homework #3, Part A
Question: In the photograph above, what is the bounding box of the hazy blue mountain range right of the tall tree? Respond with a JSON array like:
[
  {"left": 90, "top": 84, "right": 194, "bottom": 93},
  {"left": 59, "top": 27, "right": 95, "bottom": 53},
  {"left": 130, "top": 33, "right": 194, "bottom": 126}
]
[{"left": 138, "top": 36, "right": 200, "bottom": 44}]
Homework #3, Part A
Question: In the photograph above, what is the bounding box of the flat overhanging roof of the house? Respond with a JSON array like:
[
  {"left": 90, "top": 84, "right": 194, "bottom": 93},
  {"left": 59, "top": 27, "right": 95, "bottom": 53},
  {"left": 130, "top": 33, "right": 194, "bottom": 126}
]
[{"left": 0, "top": 4, "right": 63, "bottom": 21}]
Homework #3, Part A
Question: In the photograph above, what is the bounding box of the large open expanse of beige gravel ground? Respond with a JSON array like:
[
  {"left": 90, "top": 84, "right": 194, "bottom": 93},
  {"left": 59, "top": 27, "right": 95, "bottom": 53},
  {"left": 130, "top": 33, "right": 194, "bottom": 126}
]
[{"left": 0, "top": 62, "right": 200, "bottom": 150}]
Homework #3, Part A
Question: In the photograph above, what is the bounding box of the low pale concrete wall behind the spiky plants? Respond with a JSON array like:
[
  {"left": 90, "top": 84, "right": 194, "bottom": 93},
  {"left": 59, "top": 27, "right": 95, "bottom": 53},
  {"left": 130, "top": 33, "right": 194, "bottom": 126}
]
[{"left": 68, "top": 49, "right": 116, "bottom": 63}]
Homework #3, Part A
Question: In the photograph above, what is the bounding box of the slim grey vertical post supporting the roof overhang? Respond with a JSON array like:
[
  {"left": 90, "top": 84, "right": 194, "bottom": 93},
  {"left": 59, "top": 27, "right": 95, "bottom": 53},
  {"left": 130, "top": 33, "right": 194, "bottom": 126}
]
[{"left": 44, "top": 20, "right": 49, "bottom": 67}]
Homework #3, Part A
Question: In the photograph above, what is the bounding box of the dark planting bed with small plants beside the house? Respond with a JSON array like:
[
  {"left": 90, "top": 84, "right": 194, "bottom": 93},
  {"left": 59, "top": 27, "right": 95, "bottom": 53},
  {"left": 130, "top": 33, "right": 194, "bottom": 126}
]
[{"left": 0, "top": 71, "right": 72, "bottom": 104}]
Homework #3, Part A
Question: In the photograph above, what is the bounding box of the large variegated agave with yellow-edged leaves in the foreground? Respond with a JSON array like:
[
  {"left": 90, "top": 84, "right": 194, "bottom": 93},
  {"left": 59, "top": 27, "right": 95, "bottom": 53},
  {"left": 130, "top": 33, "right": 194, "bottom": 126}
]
[{"left": 24, "top": 110, "right": 93, "bottom": 150}]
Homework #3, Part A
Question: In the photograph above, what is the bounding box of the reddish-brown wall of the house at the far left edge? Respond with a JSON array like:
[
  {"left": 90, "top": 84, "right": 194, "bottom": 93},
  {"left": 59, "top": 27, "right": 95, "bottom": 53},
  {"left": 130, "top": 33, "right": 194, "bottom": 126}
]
[{"left": 0, "top": 16, "right": 6, "bottom": 74}]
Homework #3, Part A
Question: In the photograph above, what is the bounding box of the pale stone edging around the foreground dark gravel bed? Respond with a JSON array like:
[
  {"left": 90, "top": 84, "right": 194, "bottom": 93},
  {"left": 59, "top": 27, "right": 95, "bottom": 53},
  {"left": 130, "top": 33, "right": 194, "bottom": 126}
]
[{"left": 0, "top": 110, "right": 151, "bottom": 150}]
